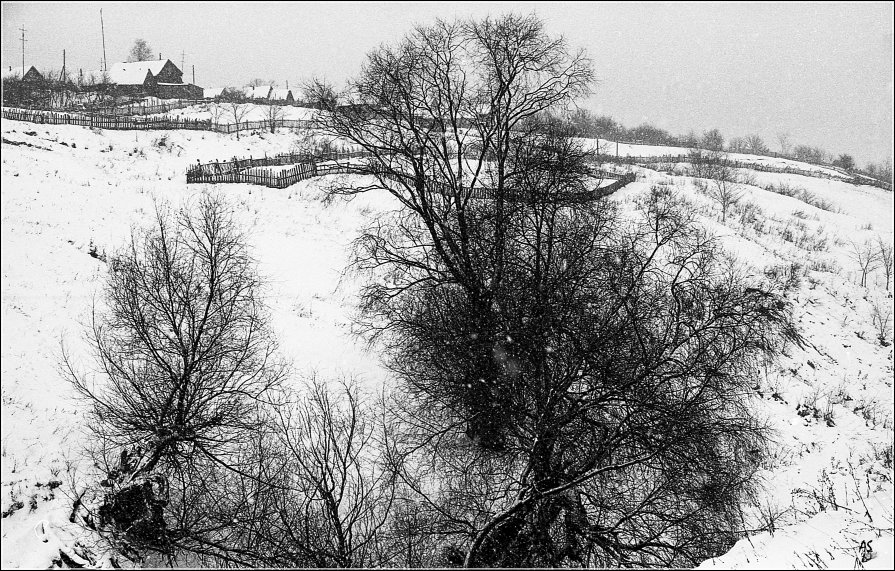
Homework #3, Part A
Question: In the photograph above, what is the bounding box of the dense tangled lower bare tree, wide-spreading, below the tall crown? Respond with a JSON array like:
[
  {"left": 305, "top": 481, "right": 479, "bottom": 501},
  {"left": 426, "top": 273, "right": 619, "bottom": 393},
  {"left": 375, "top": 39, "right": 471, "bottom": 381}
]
[{"left": 383, "top": 184, "right": 797, "bottom": 566}]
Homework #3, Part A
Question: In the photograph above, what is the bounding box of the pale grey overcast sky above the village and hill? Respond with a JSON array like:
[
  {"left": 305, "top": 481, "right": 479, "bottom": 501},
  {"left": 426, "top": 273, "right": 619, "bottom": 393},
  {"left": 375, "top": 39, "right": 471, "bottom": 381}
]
[{"left": 2, "top": 2, "right": 893, "bottom": 164}]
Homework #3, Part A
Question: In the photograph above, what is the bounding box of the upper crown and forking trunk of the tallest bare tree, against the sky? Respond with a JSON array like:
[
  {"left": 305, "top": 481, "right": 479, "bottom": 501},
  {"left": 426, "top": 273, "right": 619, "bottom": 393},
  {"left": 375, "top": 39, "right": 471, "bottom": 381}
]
[{"left": 313, "top": 12, "right": 593, "bottom": 315}]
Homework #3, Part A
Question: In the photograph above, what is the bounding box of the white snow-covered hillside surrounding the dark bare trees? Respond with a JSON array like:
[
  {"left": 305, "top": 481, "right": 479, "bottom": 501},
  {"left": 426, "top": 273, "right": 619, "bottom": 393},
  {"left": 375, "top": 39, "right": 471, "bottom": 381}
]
[{"left": 0, "top": 118, "right": 895, "bottom": 569}]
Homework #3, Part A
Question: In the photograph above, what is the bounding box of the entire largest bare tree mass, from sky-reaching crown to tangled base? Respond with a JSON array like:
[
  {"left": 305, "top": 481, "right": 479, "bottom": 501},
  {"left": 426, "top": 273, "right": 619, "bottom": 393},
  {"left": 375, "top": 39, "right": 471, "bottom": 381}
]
[{"left": 310, "top": 16, "right": 797, "bottom": 566}]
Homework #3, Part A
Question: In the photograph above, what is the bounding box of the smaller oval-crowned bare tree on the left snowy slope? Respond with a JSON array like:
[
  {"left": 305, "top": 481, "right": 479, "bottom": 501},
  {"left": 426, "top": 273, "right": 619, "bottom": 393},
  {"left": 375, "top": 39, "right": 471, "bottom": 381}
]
[{"left": 63, "top": 195, "right": 283, "bottom": 553}]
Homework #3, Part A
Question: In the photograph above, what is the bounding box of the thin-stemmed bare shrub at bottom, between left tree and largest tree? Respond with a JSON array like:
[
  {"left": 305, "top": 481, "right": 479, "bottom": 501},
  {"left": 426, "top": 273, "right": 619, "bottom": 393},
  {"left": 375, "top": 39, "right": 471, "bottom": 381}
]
[{"left": 230, "top": 377, "right": 395, "bottom": 568}]
